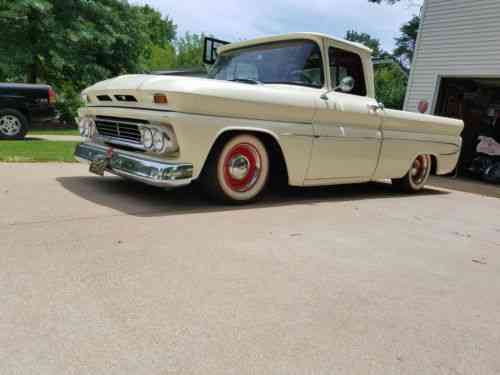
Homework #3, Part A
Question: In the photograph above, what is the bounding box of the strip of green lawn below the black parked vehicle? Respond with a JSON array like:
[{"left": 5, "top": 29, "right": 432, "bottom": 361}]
[{"left": 0, "top": 141, "right": 79, "bottom": 163}]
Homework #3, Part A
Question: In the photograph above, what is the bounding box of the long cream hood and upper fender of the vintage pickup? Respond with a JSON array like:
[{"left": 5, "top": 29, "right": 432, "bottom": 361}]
[{"left": 83, "top": 75, "right": 321, "bottom": 123}]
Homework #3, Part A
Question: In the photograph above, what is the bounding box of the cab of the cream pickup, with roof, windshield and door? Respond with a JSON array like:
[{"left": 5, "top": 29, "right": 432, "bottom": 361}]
[{"left": 209, "top": 33, "right": 384, "bottom": 185}]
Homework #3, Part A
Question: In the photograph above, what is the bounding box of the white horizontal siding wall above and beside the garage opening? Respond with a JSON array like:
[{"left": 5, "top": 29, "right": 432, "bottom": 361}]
[{"left": 405, "top": 0, "right": 500, "bottom": 111}]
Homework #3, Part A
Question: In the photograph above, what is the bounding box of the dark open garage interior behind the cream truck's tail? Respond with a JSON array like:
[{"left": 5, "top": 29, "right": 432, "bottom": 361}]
[{"left": 435, "top": 78, "right": 500, "bottom": 185}]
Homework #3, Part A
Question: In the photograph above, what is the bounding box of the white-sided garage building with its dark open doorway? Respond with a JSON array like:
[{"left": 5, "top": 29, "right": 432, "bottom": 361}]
[{"left": 404, "top": 0, "right": 500, "bottom": 180}]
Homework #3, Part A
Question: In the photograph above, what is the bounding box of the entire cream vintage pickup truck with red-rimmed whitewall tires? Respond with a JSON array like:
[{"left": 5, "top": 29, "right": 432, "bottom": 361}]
[{"left": 75, "top": 33, "right": 463, "bottom": 203}]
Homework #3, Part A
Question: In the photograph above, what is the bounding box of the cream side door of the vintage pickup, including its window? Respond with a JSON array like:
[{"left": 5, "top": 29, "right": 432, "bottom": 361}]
[{"left": 306, "top": 45, "right": 383, "bottom": 183}]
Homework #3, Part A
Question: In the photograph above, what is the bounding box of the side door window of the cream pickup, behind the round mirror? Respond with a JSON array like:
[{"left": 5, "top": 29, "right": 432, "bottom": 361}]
[{"left": 328, "top": 47, "right": 366, "bottom": 96}]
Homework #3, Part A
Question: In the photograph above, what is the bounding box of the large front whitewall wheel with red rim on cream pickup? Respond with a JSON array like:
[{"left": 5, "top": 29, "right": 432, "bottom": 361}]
[{"left": 201, "top": 134, "right": 269, "bottom": 203}]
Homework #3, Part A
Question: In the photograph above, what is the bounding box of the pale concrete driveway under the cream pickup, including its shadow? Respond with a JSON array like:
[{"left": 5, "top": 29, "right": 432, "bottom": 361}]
[{"left": 0, "top": 164, "right": 500, "bottom": 375}]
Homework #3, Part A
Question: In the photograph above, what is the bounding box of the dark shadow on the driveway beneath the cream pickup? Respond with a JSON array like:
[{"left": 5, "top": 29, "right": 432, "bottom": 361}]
[{"left": 57, "top": 176, "right": 448, "bottom": 217}]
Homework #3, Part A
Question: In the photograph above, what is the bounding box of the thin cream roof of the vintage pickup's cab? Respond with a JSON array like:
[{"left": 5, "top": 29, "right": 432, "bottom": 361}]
[{"left": 218, "top": 32, "right": 372, "bottom": 55}]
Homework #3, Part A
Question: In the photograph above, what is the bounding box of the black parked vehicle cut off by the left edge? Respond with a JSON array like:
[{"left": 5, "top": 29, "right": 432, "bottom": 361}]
[{"left": 0, "top": 83, "right": 57, "bottom": 139}]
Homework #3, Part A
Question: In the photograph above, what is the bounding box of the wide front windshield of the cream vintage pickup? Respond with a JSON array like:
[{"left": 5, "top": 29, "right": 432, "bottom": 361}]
[{"left": 208, "top": 40, "right": 324, "bottom": 87}]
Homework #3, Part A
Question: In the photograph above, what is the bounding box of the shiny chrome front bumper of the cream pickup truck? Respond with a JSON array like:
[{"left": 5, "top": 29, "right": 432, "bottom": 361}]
[{"left": 75, "top": 143, "right": 193, "bottom": 188}]
